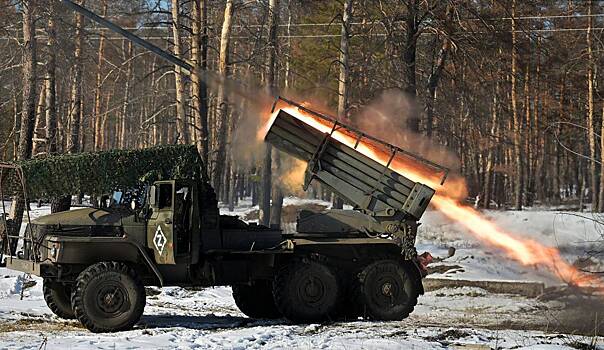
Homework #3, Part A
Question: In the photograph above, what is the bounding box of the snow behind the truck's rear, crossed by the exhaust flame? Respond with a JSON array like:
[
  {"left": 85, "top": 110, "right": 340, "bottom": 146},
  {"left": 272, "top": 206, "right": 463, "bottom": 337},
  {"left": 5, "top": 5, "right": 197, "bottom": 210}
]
[{"left": 417, "top": 206, "right": 604, "bottom": 286}]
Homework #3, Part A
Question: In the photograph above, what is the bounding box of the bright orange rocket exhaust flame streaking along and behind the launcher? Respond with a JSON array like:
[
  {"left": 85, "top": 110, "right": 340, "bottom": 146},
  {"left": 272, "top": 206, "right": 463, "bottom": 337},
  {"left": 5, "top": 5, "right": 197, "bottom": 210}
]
[{"left": 258, "top": 106, "right": 604, "bottom": 291}]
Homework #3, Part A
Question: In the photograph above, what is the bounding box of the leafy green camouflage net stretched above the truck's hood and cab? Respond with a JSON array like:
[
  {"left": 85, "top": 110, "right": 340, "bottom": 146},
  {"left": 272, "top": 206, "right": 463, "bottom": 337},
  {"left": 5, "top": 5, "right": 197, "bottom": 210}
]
[{"left": 2, "top": 145, "right": 205, "bottom": 198}]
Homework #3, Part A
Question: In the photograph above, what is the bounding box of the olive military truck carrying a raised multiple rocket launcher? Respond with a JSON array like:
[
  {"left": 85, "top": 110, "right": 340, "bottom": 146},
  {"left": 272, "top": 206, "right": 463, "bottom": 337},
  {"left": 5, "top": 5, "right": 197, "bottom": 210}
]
[{"left": 0, "top": 1, "right": 448, "bottom": 332}]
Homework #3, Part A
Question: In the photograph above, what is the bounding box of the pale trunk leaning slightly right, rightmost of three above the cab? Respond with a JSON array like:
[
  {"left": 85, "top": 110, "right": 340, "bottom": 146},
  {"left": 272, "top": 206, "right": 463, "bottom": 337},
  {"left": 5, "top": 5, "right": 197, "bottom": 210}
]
[{"left": 212, "top": 0, "right": 233, "bottom": 193}]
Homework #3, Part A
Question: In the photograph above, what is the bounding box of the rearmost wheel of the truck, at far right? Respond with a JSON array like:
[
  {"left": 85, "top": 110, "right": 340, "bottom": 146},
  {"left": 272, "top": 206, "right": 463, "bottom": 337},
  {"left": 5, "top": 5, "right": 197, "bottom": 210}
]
[{"left": 359, "top": 260, "right": 419, "bottom": 321}]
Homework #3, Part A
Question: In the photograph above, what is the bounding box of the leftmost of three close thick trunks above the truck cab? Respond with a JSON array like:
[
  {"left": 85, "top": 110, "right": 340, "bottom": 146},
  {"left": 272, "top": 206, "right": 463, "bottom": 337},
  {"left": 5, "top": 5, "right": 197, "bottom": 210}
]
[{"left": 172, "top": 0, "right": 189, "bottom": 144}]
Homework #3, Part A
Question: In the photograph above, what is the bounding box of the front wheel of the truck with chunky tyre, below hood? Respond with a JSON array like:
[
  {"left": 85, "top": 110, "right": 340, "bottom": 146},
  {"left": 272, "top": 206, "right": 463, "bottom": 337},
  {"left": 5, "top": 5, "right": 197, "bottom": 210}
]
[{"left": 71, "top": 262, "right": 145, "bottom": 333}]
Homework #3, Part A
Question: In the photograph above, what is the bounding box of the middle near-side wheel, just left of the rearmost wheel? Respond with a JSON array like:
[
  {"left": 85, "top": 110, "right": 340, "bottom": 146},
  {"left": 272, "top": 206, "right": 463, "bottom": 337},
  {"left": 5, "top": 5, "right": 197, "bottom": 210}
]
[{"left": 273, "top": 262, "right": 341, "bottom": 322}]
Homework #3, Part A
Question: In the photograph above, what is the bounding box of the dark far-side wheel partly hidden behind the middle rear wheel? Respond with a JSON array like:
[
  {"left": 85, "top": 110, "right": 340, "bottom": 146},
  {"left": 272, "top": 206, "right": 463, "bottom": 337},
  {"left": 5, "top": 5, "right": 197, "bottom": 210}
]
[{"left": 233, "top": 281, "right": 281, "bottom": 319}]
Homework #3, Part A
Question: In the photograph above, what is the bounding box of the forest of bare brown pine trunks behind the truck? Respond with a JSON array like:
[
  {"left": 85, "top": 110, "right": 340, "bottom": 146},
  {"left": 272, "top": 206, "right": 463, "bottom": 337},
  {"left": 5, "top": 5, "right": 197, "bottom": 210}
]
[{"left": 0, "top": 0, "right": 604, "bottom": 224}]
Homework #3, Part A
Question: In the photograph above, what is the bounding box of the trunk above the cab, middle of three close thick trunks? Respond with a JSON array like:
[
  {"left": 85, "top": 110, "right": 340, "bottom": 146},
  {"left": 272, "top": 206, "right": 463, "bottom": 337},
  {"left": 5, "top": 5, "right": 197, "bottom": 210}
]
[{"left": 191, "top": 0, "right": 209, "bottom": 165}]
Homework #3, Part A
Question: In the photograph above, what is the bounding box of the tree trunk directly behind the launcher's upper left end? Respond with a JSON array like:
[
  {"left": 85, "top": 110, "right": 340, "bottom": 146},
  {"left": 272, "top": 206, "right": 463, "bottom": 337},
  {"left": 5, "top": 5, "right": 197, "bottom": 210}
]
[{"left": 259, "top": 0, "right": 283, "bottom": 226}]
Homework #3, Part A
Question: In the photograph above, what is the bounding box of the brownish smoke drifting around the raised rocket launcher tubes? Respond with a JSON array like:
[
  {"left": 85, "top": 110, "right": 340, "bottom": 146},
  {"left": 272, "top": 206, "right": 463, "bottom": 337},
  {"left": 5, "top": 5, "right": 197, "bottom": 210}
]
[{"left": 200, "top": 71, "right": 467, "bottom": 198}]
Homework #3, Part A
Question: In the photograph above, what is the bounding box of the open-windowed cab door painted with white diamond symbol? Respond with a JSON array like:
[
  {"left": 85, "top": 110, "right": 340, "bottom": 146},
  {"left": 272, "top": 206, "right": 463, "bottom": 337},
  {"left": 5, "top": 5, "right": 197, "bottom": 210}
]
[{"left": 147, "top": 181, "right": 176, "bottom": 264}]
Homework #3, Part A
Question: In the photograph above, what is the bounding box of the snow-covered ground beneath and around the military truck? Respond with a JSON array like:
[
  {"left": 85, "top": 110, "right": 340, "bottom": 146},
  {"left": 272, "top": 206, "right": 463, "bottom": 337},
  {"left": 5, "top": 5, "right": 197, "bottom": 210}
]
[{"left": 0, "top": 198, "right": 604, "bottom": 349}]
